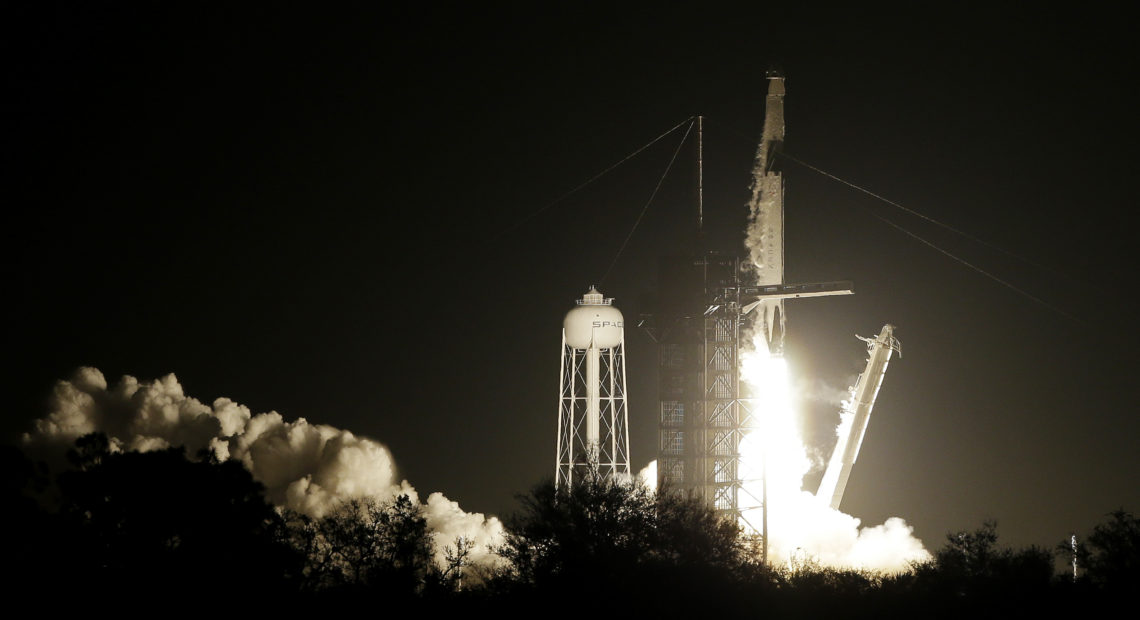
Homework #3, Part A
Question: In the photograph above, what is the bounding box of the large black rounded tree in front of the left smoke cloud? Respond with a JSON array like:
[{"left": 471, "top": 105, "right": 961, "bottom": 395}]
[{"left": 58, "top": 435, "right": 300, "bottom": 597}]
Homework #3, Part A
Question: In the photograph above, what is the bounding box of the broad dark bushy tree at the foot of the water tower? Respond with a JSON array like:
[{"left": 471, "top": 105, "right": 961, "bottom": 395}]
[{"left": 492, "top": 476, "right": 749, "bottom": 614}]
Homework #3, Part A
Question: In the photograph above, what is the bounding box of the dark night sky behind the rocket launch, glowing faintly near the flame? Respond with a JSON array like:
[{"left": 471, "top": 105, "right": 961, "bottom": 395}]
[{"left": 2, "top": 2, "right": 1140, "bottom": 546}]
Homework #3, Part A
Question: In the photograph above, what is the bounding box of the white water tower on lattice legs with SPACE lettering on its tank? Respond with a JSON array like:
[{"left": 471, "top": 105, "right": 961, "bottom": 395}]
[{"left": 554, "top": 287, "right": 630, "bottom": 486}]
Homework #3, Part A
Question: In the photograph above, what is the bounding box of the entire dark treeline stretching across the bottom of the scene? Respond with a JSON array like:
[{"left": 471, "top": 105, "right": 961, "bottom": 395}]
[{"left": 0, "top": 434, "right": 1140, "bottom": 618}]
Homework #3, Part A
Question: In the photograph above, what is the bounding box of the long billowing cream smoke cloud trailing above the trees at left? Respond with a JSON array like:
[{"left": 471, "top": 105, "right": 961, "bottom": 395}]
[{"left": 24, "top": 368, "right": 504, "bottom": 572}]
